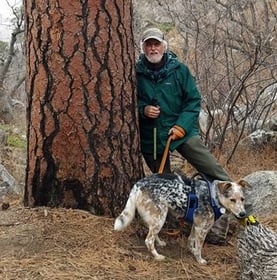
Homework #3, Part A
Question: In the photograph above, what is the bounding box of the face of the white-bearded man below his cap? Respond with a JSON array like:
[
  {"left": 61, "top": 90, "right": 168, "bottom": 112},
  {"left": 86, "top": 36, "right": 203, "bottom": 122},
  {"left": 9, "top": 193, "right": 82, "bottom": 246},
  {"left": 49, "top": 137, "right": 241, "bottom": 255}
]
[{"left": 143, "top": 39, "right": 165, "bottom": 63}]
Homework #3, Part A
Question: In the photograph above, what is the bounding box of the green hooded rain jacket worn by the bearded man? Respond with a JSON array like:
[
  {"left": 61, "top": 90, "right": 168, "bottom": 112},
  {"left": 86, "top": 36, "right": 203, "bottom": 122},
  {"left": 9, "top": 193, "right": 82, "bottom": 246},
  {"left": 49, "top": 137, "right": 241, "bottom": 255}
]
[{"left": 136, "top": 52, "right": 201, "bottom": 155}]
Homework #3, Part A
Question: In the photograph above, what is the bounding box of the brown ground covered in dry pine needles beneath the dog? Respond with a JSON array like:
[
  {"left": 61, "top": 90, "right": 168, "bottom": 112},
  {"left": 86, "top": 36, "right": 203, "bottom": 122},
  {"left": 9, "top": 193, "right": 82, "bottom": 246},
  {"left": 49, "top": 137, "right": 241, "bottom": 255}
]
[{"left": 0, "top": 196, "right": 276, "bottom": 280}]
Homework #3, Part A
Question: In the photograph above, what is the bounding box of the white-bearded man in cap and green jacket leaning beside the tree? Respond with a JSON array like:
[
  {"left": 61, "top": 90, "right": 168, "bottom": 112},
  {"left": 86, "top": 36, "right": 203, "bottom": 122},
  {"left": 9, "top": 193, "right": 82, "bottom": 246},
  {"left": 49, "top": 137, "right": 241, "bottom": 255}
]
[{"left": 136, "top": 28, "right": 231, "bottom": 181}]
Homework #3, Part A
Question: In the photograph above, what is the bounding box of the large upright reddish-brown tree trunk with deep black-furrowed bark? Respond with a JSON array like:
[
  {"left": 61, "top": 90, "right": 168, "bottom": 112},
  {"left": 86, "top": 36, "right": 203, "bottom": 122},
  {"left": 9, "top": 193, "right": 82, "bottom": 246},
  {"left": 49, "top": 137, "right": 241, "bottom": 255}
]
[{"left": 24, "top": 0, "right": 143, "bottom": 216}]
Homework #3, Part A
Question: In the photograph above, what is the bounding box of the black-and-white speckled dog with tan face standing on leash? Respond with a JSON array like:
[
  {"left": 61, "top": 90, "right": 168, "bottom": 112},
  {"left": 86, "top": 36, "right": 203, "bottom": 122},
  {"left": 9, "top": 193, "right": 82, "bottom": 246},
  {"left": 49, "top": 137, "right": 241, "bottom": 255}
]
[{"left": 114, "top": 174, "right": 249, "bottom": 264}]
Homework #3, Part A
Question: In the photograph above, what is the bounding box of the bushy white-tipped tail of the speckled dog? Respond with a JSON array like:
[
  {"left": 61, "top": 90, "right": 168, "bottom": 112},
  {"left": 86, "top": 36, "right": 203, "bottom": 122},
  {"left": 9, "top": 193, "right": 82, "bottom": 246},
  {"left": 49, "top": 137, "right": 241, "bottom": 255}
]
[{"left": 114, "top": 185, "right": 138, "bottom": 231}]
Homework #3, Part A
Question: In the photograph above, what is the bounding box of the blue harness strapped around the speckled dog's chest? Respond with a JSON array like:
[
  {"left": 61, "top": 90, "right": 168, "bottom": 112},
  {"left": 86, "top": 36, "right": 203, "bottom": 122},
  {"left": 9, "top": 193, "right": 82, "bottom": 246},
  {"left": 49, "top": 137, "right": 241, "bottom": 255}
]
[{"left": 184, "top": 174, "right": 225, "bottom": 223}]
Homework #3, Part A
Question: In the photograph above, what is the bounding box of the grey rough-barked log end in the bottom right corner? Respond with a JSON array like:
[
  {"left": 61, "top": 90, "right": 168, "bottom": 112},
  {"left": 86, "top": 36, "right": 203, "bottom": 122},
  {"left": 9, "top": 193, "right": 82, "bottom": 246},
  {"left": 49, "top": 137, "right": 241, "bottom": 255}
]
[{"left": 235, "top": 224, "right": 277, "bottom": 280}]
